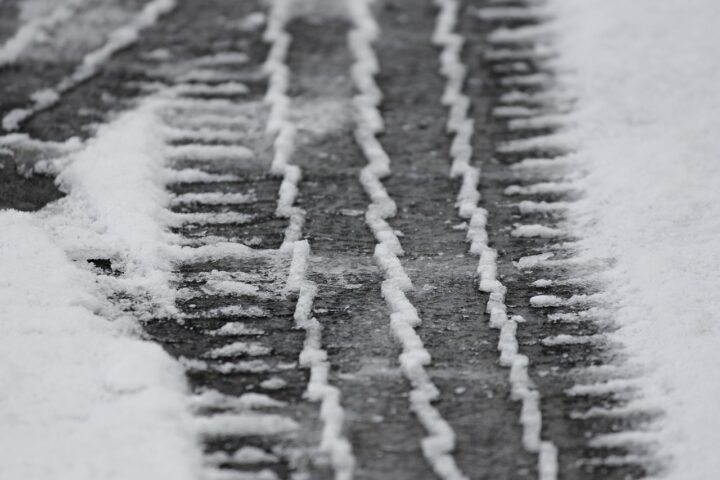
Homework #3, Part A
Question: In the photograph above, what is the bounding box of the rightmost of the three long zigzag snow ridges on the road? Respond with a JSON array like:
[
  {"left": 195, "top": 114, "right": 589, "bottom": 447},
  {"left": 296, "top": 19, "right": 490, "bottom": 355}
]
[{"left": 433, "top": 0, "right": 558, "bottom": 480}]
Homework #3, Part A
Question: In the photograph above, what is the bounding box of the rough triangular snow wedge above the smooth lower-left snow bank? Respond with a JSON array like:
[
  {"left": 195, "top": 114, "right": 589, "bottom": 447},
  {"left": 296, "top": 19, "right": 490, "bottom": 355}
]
[{"left": 39, "top": 102, "right": 176, "bottom": 316}]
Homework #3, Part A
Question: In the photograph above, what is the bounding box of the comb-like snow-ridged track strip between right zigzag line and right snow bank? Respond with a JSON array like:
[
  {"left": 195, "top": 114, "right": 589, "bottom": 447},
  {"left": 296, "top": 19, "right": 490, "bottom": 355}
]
[{"left": 463, "top": 1, "right": 655, "bottom": 479}]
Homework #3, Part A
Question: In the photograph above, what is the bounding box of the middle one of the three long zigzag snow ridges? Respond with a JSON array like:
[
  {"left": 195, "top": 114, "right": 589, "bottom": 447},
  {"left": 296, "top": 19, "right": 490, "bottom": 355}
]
[{"left": 347, "top": 0, "right": 467, "bottom": 480}]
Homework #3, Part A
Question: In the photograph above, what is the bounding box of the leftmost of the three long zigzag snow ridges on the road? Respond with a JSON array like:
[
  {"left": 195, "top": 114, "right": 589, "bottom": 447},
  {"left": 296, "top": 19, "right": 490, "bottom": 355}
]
[{"left": 263, "top": 0, "right": 355, "bottom": 480}]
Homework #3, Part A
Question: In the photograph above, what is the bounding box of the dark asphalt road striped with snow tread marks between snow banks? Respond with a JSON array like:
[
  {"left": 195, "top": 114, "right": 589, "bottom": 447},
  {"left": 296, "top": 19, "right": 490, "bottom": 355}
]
[{"left": 0, "top": 0, "right": 652, "bottom": 480}]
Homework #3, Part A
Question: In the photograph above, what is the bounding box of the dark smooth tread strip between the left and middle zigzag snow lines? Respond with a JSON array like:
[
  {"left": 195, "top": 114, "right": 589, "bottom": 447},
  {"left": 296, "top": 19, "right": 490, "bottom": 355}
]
[{"left": 289, "top": 11, "right": 432, "bottom": 480}]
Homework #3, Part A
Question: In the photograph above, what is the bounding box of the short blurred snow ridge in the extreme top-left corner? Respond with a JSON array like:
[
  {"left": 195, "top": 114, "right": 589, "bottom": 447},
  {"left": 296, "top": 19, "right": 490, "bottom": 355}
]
[{"left": 0, "top": 0, "right": 87, "bottom": 67}]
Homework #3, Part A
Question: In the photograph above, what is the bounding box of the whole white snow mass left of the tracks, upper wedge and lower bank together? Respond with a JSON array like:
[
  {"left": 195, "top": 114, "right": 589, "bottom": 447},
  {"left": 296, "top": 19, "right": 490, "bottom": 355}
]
[{"left": 0, "top": 102, "right": 201, "bottom": 480}]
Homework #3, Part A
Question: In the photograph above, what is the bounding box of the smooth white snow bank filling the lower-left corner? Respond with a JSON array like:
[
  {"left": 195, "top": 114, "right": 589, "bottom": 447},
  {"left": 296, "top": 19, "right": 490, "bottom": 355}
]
[{"left": 0, "top": 211, "right": 201, "bottom": 480}]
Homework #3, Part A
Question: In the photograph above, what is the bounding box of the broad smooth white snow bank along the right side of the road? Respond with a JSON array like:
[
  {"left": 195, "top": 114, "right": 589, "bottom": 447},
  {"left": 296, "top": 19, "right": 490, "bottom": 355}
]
[{"left": 550, "top": 0, "right": 720, "bottom": 480}]
